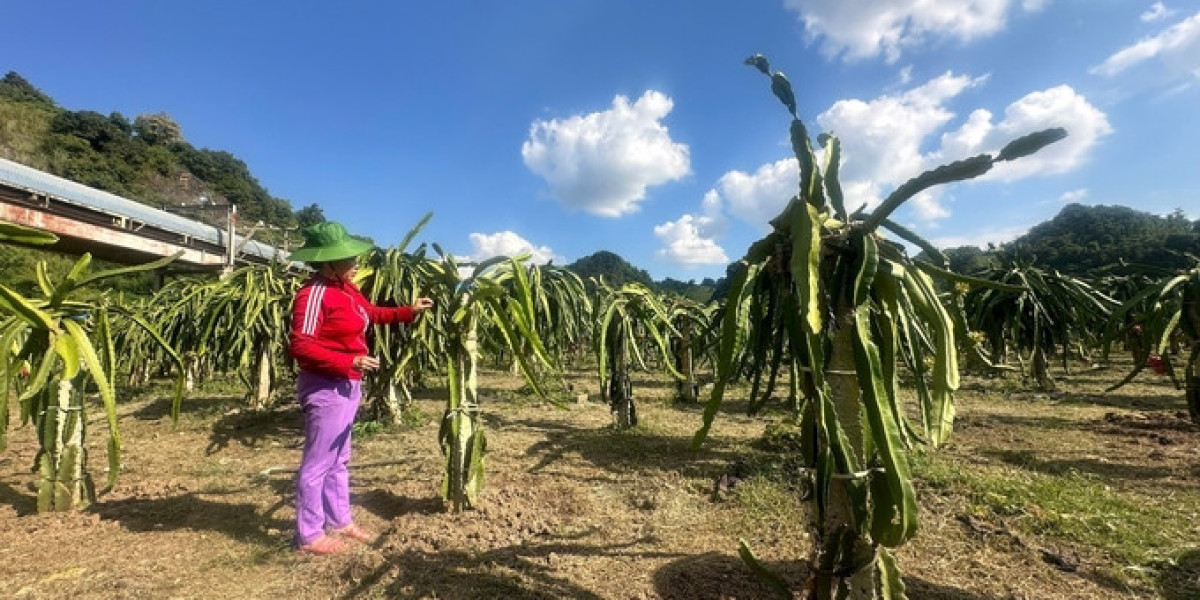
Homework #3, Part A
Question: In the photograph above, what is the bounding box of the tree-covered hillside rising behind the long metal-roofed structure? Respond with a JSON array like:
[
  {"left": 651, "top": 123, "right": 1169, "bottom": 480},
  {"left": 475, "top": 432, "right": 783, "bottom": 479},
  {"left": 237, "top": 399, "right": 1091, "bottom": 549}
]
[{"left": 0, "top": 72, "right": 324, "bottom": 241}]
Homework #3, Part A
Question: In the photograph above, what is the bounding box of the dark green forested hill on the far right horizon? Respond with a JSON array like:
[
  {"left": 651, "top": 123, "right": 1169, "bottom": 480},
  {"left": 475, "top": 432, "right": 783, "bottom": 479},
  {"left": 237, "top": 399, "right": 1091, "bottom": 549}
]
[{"left": 947, "top": 204, "right": 1200, "bottom": 276}]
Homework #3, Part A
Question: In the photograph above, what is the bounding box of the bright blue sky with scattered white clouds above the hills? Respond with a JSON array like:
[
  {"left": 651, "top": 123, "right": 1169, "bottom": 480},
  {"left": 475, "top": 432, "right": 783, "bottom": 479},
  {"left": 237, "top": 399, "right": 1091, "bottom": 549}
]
[{"left": 0, "top": 0, "right": 1200, "bottom": 280}]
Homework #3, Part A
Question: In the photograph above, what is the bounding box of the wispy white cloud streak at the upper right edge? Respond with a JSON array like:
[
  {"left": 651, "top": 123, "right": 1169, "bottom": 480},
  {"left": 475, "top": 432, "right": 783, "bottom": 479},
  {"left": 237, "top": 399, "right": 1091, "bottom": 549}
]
[{"left": 1090, "top": 13, "right": 1200, "bottom": 80}]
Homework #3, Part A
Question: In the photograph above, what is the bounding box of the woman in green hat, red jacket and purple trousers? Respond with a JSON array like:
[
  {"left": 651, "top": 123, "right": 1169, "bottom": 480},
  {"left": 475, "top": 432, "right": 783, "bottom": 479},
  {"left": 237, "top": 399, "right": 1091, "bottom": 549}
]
[{"left": 290, "top": 221, "right": 433, "bottom": 554}]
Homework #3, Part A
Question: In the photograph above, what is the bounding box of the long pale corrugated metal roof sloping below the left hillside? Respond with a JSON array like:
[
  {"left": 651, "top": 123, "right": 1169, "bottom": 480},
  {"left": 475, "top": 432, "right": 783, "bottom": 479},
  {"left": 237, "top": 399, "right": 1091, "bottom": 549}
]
[{"left": 0, "top": 158, "right": 286, "bottom": 260}]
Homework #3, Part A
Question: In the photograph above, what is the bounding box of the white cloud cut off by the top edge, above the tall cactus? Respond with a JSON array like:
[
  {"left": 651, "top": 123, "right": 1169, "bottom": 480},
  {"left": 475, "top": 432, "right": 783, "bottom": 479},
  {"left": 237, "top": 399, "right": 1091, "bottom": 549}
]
[{"left": 784, "top": 0, "right": 1049, "bottom": 62}]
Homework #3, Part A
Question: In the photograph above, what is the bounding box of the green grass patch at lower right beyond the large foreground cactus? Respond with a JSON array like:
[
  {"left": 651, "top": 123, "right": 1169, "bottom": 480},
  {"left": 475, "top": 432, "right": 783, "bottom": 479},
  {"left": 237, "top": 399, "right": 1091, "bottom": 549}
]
[{"left": 913, "top": 455, "right": 1200, "bottom": 566}]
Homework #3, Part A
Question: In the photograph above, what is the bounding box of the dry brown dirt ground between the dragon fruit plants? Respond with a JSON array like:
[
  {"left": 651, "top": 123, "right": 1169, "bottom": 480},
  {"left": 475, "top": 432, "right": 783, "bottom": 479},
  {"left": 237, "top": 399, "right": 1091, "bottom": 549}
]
[{"left": 0, "top": 360, "right": 1200, "bottom": 600}]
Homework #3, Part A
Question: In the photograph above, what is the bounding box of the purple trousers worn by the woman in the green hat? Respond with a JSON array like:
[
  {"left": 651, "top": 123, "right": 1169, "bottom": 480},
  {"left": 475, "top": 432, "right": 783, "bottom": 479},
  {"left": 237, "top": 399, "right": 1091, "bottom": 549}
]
[{"left": 296, "top": 371, "right": 362, "bottom": 546}]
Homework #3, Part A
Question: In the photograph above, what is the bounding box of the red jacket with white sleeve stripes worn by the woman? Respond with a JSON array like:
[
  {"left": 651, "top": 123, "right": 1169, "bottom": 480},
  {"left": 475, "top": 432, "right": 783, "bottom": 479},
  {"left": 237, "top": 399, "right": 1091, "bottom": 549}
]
[{"left": 289, "top": 275, "right": 416, "bottom": 379}]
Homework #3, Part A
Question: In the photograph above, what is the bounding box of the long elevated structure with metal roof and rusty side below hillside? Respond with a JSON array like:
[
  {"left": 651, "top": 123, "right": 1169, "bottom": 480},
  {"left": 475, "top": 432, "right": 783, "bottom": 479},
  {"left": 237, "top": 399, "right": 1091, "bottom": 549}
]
[{"left": 0, "top": 158, "right": 288, "bottom": 265}]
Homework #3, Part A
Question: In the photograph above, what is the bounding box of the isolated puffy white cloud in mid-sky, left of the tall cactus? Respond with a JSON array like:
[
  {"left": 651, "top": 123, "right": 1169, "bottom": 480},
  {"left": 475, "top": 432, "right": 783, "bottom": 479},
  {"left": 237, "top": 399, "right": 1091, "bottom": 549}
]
[{"left": 521, "top": 90, "right": 691, "bottom": 217}]
